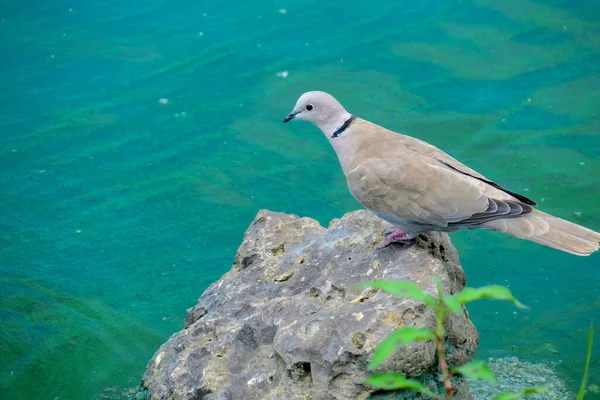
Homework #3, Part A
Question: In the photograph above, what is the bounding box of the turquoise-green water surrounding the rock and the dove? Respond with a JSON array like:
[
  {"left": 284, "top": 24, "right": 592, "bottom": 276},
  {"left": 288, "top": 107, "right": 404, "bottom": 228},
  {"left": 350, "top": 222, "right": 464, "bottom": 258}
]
[{"left": 0, "top": 0, "right": 600, "bottom": 399}]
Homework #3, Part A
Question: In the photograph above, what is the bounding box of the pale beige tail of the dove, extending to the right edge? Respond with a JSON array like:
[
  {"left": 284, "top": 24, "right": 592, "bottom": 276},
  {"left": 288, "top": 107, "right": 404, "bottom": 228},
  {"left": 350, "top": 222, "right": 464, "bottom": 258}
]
[{"left": 482, "top": 210, "right": 600, "bottom": 256}]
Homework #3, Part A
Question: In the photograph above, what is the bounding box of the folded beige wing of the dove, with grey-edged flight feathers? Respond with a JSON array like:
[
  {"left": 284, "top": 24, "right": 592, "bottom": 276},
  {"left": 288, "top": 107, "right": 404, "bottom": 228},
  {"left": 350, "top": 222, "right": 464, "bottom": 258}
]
[{"left": 347, "top": 149, "right": 531, "bottom": 228}]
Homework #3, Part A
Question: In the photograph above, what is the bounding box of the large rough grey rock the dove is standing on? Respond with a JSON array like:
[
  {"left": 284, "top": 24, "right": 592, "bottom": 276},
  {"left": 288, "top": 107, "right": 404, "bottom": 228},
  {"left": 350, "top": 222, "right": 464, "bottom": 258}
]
[{"left": 142, "top": 210, "right": 479, "bottom": 400}]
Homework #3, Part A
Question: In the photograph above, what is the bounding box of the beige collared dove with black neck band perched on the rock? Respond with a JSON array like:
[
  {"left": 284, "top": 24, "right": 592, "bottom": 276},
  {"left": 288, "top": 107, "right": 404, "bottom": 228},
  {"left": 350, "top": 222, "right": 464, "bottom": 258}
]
[{"left": 283, "top": 91, "right": 600, "bottom": 256}]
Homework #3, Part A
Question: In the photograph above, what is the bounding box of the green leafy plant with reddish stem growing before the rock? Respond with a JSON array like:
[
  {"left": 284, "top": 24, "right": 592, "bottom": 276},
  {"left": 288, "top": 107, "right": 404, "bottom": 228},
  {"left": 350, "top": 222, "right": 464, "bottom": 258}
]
[{"left": 360, "top": 279, "right": 548, "bottom": 400}]
